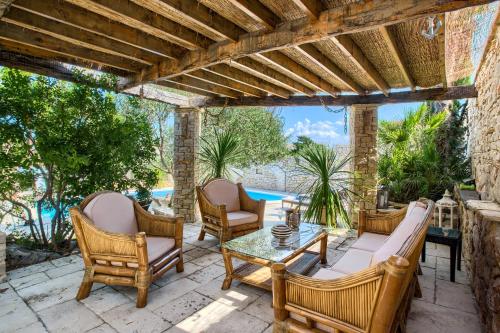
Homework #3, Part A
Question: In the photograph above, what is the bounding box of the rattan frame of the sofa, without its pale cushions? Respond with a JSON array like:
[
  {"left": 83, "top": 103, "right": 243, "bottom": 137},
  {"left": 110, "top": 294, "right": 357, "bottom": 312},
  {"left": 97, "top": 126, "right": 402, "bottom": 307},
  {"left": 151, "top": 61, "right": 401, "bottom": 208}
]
[{"left": 272, "top": 200, "right": 434, "bottom": 333}]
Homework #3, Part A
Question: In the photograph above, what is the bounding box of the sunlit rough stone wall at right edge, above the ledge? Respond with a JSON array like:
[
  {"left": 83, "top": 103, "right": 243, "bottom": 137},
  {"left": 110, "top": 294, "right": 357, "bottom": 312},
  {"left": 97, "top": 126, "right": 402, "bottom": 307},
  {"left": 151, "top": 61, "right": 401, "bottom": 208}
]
[{"left": 468, "top": 29, "right": 500, "bottom": 202}]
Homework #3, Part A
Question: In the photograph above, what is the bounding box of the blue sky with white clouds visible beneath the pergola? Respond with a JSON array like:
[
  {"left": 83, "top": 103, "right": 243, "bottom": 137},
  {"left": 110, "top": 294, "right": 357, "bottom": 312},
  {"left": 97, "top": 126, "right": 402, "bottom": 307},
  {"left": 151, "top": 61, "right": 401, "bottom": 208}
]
[{"left": 280, "top": 103, "right": 421, "bottom": 145}]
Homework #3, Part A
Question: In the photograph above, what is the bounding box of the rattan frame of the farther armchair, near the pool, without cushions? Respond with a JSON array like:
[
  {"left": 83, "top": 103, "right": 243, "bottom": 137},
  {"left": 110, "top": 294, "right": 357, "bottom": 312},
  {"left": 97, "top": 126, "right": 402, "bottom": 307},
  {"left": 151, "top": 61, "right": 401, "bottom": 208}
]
[{"left": 196, "top": 178, "right": 266, "bottom": 244}]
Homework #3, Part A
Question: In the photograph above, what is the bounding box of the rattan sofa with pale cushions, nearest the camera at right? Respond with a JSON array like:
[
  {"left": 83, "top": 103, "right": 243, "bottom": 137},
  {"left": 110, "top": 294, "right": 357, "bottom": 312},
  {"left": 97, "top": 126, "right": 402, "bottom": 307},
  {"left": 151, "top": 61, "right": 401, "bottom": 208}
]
[{"left": 272, "top": 200, "right": 434, "bottom": 333}]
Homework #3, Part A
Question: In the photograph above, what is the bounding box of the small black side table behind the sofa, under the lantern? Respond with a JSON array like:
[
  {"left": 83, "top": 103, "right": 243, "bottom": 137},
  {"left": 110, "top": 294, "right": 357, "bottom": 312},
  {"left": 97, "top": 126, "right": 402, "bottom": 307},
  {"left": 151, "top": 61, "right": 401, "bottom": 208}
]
[{"left": 422, "top": 227, "right": 462, "bottom": 282}]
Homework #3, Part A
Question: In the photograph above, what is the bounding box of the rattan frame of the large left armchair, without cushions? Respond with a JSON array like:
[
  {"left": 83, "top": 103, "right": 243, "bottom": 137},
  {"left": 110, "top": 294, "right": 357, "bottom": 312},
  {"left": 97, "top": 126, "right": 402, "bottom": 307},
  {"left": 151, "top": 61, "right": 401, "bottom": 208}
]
[{"left": 70, "top": 192, "right": 184, "bottom": 308}]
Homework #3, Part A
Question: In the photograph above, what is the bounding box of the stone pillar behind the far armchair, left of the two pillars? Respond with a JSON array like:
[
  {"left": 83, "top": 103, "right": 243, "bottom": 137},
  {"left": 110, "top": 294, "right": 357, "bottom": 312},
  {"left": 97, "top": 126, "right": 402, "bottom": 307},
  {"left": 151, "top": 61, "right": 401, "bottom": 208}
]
[{"left": 174, "top": 108, "right": 201, "bottom": 223}]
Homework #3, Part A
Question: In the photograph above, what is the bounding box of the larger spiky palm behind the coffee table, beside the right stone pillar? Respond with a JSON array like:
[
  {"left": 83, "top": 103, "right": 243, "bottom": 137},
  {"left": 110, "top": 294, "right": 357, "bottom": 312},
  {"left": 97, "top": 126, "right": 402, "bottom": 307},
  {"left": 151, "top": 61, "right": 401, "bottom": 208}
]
[{"left": 297, "top": 144, "right": 355, "bottom": 228}]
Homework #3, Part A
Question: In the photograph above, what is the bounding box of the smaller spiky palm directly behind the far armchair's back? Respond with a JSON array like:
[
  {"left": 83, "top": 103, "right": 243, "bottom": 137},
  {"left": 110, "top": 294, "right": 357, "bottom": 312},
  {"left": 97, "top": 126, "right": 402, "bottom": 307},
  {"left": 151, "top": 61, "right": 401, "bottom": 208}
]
[{"left": 199, "top": 130, "right": 241, "bottom": 182}]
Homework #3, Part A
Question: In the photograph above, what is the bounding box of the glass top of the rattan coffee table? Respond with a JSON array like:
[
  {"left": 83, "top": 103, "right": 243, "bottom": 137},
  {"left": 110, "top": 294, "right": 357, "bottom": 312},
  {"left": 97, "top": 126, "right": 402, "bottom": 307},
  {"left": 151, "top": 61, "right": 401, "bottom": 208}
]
[{"left": 222, "top": 223, "right": 323, "bottom": 262}]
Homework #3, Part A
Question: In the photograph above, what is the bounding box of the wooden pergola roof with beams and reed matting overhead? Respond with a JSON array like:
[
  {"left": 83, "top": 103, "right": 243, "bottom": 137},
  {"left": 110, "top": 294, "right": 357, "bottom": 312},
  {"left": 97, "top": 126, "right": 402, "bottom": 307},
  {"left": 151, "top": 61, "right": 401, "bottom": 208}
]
[{"left": 0, "top": 0, "right": 492, "bottom": 106}]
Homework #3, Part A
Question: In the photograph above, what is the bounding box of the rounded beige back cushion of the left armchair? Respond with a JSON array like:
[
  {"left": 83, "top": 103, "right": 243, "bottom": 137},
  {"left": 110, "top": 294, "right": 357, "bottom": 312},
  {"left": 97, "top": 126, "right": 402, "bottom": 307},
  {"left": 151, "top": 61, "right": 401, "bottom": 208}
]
[{"left": 83, "top": 192, "right": 138, "bottom": 235}]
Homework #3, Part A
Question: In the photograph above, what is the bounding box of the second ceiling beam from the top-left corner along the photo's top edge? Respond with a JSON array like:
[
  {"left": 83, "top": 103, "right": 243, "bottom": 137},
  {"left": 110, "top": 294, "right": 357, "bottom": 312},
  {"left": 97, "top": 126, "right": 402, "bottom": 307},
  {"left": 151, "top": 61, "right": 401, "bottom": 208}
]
[{"left": 65, "top": 0, "right": 212, "bottom": 50}]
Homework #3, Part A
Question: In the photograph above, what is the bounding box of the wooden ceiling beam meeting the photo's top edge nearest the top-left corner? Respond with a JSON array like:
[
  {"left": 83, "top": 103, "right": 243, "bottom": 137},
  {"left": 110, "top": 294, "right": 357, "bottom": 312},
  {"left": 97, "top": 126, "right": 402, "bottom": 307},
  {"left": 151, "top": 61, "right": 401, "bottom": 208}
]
[{"left": 12, "top": 0, "right": 182, "bottom": 61}]
